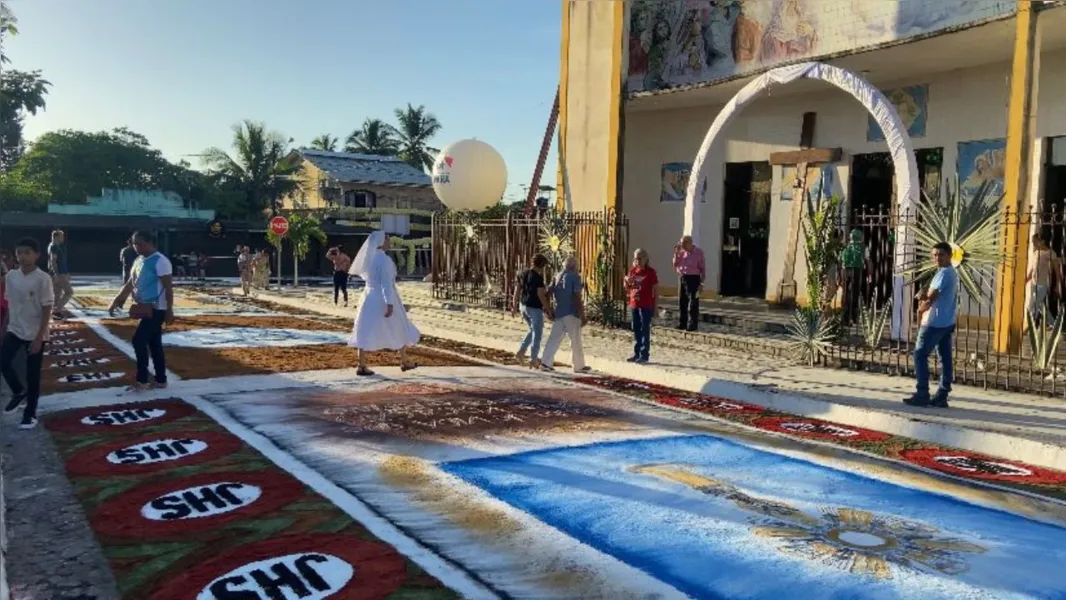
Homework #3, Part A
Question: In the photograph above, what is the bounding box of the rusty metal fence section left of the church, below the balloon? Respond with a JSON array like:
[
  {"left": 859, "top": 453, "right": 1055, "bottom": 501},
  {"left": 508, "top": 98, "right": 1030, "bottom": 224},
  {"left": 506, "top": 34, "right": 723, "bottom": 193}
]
[{"left": 432, "top": 211, "right": 629, "bottom": 313}]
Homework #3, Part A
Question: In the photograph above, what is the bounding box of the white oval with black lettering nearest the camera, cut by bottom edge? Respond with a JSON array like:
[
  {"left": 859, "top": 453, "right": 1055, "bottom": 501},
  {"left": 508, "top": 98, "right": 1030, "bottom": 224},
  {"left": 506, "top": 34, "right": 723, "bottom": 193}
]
[{"left": 209, "top": 554, "right": 329, "bottom": 600}]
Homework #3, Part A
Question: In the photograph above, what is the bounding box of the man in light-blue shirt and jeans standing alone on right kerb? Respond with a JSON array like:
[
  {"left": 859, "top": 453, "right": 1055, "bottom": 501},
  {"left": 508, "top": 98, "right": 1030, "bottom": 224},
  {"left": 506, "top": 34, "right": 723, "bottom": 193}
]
[{"left": 903, "top": 242, "right": 958, "bottom": 408}]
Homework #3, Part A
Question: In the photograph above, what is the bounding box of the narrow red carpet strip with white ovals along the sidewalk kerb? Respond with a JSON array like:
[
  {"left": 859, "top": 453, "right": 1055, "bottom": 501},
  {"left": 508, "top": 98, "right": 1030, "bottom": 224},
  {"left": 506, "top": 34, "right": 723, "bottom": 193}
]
[{"left": 576, "top": 376, "right": 1066, "bottom": 499}]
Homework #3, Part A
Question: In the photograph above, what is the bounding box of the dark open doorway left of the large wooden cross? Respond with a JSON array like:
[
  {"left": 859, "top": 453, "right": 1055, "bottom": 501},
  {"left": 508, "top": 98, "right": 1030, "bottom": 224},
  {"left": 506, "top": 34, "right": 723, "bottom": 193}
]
[{"left": 718, "top": 162, "right": 773, "bottom": 298}]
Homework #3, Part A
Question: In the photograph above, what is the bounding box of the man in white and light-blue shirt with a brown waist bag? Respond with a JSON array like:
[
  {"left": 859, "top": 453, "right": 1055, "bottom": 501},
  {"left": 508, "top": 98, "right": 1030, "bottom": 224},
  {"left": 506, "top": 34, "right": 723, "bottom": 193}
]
[{"left": 109, "top": 231, "right": 174, "bottom": 391}]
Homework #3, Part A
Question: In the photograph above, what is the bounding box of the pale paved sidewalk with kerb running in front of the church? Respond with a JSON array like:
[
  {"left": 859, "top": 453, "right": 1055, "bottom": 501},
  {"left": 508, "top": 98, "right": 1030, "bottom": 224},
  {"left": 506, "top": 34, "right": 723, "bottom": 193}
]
[{"left": 241, "top": 283, "right": 1066, "bottom": 469}]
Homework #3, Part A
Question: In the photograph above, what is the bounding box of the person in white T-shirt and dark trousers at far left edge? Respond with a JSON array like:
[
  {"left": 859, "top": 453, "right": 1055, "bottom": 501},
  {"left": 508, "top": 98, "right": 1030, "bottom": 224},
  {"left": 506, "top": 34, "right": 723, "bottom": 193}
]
[{"left": 0, "top": 239, "right": 55, "bottom": 429}]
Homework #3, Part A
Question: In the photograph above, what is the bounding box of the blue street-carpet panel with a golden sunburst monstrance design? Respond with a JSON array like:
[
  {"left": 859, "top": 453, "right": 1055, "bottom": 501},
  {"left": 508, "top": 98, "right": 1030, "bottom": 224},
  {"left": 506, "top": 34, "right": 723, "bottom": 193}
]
[{"left": 441, "top": 436, "right": 1066, "bottom": 600}]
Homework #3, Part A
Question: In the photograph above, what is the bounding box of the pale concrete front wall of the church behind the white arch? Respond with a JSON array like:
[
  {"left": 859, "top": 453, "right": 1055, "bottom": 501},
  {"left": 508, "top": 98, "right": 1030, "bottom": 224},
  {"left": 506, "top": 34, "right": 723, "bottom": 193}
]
[{"left": 623, "top": 51, "right": 1066, "bottom": 297}]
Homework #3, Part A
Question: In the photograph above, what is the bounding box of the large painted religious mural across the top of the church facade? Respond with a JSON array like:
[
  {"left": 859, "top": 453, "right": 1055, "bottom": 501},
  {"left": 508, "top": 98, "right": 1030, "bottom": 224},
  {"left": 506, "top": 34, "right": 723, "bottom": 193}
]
[{"left": 627, "top": 0, "right": 1014, "bottom": 93}]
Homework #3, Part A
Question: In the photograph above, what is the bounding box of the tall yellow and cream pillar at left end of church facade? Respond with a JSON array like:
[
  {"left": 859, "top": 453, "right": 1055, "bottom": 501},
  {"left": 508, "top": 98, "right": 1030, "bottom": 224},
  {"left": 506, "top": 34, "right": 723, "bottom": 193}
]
[{"left": 560, "top": 0, "right": 626, "bottom": 211}]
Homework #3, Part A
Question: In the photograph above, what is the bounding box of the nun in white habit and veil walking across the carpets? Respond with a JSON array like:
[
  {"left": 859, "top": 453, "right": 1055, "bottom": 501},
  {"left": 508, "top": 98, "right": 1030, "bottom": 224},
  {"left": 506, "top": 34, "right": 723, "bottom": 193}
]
[{"left": 348, "top": 231, "right": 419, "bottom": 376}]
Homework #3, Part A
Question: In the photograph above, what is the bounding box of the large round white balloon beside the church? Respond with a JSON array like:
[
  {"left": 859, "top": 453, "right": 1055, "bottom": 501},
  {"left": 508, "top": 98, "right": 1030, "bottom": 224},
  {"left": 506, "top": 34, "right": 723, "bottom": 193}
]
[{"left": 433, "top": 140, "right": 507, "bottom": 211}]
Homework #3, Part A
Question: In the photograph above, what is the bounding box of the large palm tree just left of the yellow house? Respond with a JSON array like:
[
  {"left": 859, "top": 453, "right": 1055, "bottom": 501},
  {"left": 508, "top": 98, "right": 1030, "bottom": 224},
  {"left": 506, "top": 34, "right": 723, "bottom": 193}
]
[{"left": 201, "top": 120, "right": 303, "bottom": 214}]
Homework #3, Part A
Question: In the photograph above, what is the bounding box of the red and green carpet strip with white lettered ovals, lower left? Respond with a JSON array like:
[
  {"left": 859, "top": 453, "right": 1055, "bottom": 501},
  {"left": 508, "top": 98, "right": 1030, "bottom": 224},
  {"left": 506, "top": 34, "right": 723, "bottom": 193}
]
[{"left": 45, "top": 400, "right": 457, "bottom": 600}]
